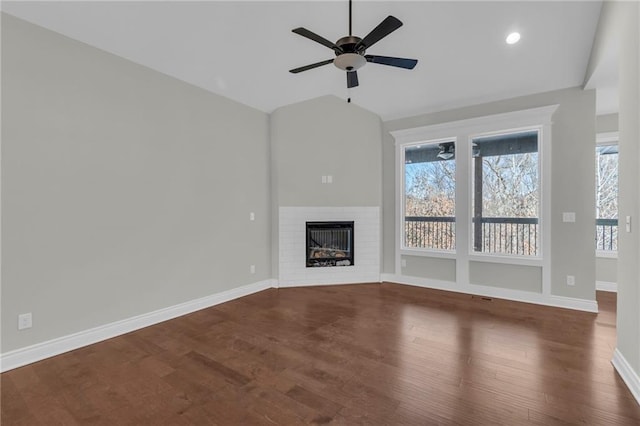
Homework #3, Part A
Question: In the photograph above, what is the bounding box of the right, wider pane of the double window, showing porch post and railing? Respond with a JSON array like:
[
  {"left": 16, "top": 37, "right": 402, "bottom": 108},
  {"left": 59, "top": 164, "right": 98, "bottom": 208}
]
[{"left": 471, "top": 130, "right": 540, "bottom": 256}]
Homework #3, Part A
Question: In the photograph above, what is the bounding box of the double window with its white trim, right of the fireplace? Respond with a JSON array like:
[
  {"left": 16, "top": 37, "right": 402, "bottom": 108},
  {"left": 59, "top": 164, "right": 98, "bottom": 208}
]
[{"left": 390, "top": 105, "right": 558, "bottom": 266}]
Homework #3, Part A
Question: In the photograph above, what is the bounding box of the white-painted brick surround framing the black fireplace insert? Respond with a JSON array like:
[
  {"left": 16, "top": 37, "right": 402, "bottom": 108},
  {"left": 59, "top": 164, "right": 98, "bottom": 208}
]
[{"left": 278, "top": 207, "right": 380, "bottom": 287}]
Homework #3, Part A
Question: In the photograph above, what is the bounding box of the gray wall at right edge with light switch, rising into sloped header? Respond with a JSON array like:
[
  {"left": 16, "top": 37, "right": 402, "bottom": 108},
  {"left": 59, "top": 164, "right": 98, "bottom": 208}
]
[{"left": 585, "top": 1, "right": 640, "bottom": 380}]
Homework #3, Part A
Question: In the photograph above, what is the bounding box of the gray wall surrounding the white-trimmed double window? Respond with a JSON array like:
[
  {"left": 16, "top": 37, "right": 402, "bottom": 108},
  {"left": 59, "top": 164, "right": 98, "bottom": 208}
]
[{"left": 383, "top": 88, "right": 595, "bottom": 300}]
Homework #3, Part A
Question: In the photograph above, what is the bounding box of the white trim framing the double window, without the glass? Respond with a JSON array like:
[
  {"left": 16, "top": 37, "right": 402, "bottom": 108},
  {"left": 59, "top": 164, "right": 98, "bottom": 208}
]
[{"left": 390, "top": 105, "right": 558, "bottom": 296}]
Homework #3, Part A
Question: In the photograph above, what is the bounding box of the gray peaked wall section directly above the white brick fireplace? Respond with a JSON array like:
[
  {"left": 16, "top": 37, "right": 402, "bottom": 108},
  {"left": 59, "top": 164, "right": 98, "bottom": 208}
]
[{"left": 270, "top": 96, "right": 382, "bottom": 210}]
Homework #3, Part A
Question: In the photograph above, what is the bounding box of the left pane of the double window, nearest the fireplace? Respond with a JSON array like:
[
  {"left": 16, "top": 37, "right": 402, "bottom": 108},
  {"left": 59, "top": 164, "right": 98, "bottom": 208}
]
[{"left": 403, "top": 140, "right": 456, "bottom": 251}]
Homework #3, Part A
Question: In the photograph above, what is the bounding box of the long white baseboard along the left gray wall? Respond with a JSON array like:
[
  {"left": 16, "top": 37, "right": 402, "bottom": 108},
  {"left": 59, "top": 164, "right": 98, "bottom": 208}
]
[{"left": 0, "top": 280, "right": 277, "bottom": 372}]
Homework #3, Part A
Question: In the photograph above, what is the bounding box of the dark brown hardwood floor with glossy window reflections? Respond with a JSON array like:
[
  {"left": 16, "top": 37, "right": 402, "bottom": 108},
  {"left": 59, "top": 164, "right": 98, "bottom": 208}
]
[{"left": 2, "top": 283, "right": 640, "bottom": 426}]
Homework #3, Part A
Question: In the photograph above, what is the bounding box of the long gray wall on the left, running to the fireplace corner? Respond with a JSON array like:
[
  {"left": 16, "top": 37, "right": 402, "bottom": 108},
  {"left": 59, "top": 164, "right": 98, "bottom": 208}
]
[{"left": 2, "top": 14, "right": 272, "bottom": 352}]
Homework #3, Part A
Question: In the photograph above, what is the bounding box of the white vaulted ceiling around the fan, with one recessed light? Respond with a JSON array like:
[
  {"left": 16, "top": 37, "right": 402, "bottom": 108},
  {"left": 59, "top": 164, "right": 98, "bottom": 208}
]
[{"left": 2, "top": 0, "right": 601, "bottom": 119}]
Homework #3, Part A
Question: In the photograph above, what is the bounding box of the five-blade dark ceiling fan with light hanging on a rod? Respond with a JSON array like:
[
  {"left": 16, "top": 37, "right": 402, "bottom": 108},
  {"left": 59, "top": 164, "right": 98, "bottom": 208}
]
[{"left": 289, "top": 0, "right": 418, "bottom": 88}]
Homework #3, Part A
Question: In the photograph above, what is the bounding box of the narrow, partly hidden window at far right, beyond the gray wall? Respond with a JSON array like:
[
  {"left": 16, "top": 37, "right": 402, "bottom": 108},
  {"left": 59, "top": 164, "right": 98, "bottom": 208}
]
[{"left": 596, "top": 138, "right": 618, "bottom": 253}]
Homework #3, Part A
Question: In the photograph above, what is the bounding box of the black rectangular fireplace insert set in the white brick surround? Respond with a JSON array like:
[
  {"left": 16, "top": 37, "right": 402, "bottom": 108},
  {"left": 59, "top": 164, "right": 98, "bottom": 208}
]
[{"left": 306, "top": 222, "right": 354, "bottom": 267}]
